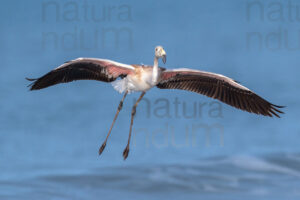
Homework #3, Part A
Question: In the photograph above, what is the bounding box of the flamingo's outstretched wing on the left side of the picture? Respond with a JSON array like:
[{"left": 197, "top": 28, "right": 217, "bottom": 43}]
[{"left": 26, "top": 58, "right": 134, "bottom": 90}]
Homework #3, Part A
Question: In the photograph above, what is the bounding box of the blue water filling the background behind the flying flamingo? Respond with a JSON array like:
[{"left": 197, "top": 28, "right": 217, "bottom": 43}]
[{"left": 0, "top": 0, "right": 300, "bottom": 200}]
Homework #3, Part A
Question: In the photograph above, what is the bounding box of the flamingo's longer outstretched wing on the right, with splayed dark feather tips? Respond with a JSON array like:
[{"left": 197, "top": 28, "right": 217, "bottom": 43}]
[{"left": 157, "top": 68, "right": 283, "bottom": 117}]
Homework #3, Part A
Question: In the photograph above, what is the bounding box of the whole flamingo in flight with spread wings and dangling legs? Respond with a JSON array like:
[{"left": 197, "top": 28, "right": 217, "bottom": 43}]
[{"left": 27, "top": 46, "right": 283, "bottom": 160}]
